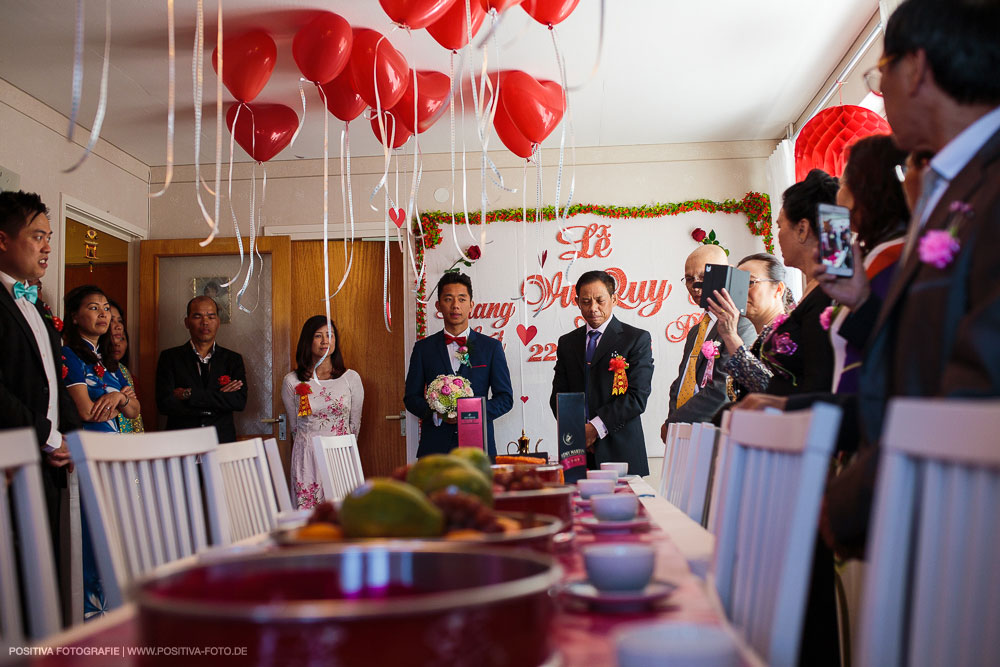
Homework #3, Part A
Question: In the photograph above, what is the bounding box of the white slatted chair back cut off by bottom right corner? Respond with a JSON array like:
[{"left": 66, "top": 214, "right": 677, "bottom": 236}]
[{"left": 856, "top": 398, "right": 1000, "bottom": 667}]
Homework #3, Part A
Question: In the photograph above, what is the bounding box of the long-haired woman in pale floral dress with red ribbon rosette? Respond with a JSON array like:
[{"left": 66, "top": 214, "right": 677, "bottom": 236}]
[{"left": 281, "top": 315, "right": 365, "bottom": 509}]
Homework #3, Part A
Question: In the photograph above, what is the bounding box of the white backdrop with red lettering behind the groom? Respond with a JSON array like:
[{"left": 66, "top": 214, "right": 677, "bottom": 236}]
[{"left": 418, "top": 210, "right": 764, "bottom": 458}]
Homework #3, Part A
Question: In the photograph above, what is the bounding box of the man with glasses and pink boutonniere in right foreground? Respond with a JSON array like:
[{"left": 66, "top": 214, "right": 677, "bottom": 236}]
[{"left": 752, "top": 0, "right": 1000, "bottom": 556}]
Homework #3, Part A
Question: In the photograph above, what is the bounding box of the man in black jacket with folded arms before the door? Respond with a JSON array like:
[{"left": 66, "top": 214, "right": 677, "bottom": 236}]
[{"left": 156, "top": 296, "right": 247, "bottom": 443}]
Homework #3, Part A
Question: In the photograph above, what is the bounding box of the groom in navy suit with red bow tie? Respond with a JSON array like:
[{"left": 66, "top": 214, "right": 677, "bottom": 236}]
[{"left": 403, "top": 273, "right": 514, "bottom": 458}]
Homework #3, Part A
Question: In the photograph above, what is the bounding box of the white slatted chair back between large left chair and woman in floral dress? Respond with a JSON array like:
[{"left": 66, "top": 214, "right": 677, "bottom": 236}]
[{"left": 216, "top": 438, "right": 278, "bottom": 542}]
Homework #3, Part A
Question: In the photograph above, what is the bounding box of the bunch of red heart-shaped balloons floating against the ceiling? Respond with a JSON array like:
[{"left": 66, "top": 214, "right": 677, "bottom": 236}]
[{"left": 212, "top": 0, "right": 579, "bottom": 162}]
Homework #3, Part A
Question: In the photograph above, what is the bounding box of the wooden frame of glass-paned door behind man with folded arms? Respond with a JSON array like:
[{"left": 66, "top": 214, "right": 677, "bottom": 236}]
[{"left": 133, "top": 236, "right": 298, "bottom": 460}]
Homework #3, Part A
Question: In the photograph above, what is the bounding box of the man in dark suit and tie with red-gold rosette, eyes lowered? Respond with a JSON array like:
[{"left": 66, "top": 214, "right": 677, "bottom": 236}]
[{"left": 549, "top": 271, "right": 653, "bottom": 475}]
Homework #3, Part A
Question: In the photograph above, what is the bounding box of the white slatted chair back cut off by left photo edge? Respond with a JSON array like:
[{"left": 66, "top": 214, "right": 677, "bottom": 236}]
[{"left": 0, "top": 428, "right": 61, "bottom": 656}]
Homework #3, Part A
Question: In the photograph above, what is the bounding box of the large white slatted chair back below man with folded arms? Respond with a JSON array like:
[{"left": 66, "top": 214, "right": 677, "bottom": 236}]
[{"left": 67, "top": 427, "right": 232, "bottom": 608}]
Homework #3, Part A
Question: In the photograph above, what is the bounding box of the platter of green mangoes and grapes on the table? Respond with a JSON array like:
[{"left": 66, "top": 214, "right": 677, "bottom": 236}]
[{"left": 274, "top": 447, "right": 566, "bottom": 551}]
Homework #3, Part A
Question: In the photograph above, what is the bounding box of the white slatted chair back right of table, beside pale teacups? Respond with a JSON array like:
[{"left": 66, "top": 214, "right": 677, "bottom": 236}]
[{"left": 712, "top": 403, "right": 840, "bottom": 665}]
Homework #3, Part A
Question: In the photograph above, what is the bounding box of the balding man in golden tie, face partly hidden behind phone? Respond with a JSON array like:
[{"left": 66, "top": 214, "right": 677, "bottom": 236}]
[{"left": 660, "top": 245, "right": 757, "bottom": 434}]
